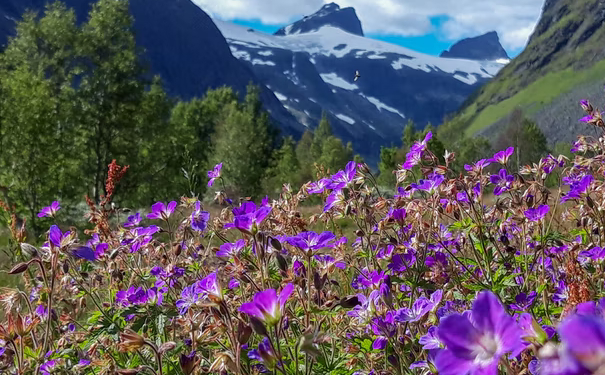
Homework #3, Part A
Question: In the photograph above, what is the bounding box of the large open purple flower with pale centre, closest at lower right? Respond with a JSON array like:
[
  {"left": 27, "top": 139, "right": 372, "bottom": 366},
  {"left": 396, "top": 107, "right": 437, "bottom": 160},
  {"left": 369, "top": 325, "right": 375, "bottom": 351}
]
[{"left": 436, "top": 291, "right": 523, "bottom": 375}]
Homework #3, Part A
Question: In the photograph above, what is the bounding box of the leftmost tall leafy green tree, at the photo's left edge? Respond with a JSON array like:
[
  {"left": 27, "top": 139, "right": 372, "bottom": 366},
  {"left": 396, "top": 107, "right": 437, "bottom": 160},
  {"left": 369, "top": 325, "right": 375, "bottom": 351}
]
[{"left": 0, "top": 4, "right": 79, "bottom": 231}]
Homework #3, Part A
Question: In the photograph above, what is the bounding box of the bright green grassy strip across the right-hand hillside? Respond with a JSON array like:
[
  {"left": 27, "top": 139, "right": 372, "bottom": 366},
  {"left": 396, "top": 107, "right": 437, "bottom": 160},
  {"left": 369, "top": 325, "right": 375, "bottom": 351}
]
[{"left": 462, "top": 60, "right": 605, "bottom": 136}]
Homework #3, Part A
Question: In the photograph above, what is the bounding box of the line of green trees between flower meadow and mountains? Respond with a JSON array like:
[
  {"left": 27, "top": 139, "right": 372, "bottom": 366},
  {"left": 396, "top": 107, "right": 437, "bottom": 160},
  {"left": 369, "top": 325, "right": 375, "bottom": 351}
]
[{"left": 0, "top": 0, "right": 560, "bottom": 234}]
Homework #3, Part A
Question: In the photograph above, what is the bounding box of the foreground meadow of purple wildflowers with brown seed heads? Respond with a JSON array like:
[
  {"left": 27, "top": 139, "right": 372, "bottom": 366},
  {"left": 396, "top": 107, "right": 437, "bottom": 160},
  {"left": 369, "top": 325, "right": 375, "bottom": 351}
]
[{"left": 0, "top": 97, "right": 605, "bottom": 375}]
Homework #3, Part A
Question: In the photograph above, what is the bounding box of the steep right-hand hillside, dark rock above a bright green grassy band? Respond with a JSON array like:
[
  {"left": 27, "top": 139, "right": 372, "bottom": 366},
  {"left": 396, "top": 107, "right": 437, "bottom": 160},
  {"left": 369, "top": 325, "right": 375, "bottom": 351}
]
[{"left": 446, "top": 0, "right": 605, "bottom": 136}]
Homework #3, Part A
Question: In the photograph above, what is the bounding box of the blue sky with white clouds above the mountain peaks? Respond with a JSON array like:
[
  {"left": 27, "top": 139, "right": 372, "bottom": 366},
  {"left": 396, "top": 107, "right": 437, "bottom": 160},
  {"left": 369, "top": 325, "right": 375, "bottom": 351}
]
[{"left": 193, "top": 0, "right": 543, "bottom": 49}]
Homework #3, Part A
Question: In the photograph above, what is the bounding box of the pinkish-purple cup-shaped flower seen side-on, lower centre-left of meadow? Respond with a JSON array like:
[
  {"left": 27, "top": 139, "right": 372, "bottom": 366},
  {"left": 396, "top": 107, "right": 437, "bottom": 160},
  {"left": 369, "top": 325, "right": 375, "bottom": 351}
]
[{"left": 239, "top": 284, "right": 294, "bottom": 325}]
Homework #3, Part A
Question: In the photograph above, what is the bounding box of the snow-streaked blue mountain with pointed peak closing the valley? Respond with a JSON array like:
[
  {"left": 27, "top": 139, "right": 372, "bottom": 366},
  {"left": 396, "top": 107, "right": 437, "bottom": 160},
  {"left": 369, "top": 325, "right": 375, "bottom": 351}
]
[{"left": 214, "top": 5, "right": 504, "bottom": 162}]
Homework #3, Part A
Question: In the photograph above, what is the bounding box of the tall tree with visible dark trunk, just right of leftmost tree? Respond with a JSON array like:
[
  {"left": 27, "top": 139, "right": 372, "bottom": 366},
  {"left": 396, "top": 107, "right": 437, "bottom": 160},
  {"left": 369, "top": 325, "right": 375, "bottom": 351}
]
[{"left": 78, "top": 0, "right": 146, "bottom": 204}]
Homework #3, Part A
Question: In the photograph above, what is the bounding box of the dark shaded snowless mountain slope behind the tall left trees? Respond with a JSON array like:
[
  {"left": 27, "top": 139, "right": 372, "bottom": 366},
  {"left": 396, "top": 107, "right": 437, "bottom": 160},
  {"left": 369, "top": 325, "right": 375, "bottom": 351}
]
[{"left": 0, "top": 0, "right": 304, "bottom": 136}]
